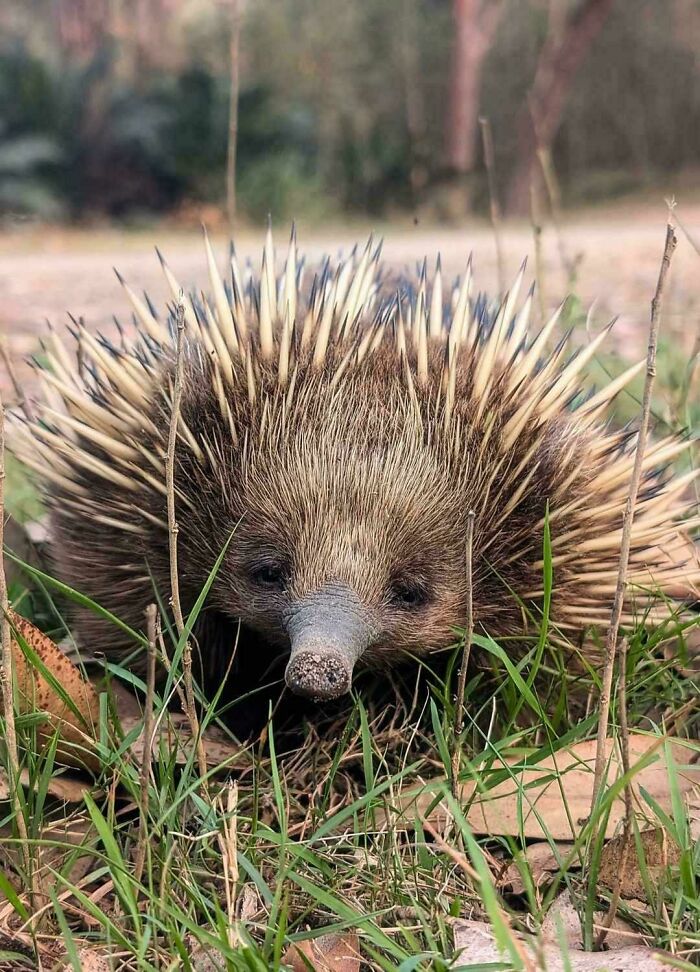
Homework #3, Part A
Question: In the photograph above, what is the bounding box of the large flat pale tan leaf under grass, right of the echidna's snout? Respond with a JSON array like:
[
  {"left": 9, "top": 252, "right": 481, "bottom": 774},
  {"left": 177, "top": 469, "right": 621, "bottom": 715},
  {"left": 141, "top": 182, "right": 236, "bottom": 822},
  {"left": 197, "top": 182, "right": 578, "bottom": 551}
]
[{"left": 386, "top": 733, "right": 700, "bottom": 841}]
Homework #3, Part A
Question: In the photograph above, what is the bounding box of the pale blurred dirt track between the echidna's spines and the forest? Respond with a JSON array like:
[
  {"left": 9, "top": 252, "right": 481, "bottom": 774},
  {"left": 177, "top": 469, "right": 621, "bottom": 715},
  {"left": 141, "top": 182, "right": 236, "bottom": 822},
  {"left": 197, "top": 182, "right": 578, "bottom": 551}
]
[{"left": 0, "top": 199, "right": 700, "bottom": 394}]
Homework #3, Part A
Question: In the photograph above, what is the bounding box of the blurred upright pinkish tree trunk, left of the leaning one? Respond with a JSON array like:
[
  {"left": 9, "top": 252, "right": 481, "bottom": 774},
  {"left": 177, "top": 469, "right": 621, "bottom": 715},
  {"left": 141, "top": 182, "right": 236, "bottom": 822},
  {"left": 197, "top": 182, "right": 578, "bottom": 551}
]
[{"left": 445, "top": 0, "right": 505, "bottom": 175}]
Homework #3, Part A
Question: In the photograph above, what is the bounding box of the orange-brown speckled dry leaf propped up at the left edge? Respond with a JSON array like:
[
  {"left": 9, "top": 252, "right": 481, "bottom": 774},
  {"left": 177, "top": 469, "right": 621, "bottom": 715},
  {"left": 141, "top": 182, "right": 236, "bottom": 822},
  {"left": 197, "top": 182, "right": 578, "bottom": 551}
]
[{"left": 9, "top": 610, "right": 100, "bottom": 770}]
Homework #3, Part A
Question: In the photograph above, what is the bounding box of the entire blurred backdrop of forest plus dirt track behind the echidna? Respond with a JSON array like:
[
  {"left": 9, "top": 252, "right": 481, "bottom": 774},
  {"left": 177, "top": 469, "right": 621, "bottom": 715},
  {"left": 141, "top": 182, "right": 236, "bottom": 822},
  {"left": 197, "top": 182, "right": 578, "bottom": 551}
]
[{"left": 0, "top": 0, "right": 700, "bottom": 430}]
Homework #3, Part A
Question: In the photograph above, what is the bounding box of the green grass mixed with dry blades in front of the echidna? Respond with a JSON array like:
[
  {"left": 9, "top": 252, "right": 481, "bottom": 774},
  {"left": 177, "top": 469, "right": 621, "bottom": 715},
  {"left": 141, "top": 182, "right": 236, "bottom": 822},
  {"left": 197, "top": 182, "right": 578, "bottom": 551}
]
[{"left": 0, "top": 338, "right": 700, "bottom": 972}]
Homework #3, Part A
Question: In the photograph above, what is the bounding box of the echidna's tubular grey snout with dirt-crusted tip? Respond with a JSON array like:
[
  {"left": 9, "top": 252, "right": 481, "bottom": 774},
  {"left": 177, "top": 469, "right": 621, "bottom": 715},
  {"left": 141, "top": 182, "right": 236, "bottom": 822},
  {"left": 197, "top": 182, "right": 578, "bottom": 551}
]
[{"left": 285, "top": 584, "right": 374, "bottom": 699}]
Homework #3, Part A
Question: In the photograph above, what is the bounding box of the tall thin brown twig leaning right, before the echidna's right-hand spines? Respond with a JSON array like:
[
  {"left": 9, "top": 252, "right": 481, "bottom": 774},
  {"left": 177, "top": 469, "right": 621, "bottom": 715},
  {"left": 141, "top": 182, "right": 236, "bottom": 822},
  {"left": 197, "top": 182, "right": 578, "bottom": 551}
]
[{"left": 591, "top": 205, "right": 678, "bottom": 813}]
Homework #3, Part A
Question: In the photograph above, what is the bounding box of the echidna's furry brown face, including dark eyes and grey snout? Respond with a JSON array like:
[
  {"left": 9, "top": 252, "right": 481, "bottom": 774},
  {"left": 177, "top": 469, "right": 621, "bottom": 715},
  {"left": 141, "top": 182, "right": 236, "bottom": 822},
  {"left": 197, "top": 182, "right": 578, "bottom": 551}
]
[{"left": 202, "top": 355, "right": 464, "bottom": 699}]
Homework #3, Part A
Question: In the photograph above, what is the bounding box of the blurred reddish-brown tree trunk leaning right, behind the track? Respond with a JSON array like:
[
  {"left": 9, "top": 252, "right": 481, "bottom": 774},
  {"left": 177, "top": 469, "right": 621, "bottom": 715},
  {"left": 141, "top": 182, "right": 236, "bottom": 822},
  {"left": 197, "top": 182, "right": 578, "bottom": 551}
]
[{"left": 506, "top": 0, "right": 615, "bottom": 215}]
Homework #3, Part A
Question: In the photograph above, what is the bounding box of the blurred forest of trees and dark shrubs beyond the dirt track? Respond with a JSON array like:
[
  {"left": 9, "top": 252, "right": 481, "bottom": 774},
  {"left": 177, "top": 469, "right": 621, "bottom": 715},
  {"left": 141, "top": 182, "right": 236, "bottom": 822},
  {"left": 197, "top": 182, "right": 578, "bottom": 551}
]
[{"left": 0, "top": 0, "right": 700, "bottom": 221}]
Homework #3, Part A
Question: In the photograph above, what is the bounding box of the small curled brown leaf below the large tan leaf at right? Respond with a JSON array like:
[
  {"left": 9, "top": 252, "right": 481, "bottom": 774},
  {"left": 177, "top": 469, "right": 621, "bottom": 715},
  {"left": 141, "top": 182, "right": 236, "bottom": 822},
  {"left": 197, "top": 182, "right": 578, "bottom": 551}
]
[{"left": 598, "top": 827, "right": 681, "bottom": 900}]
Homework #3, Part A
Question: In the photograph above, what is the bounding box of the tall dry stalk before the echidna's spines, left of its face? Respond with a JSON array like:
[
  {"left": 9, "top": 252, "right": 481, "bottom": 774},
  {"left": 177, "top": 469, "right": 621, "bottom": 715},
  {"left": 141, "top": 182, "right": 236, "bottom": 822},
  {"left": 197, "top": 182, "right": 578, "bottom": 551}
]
[{"left": 165, "top": 291, "right": 207, "bottom": 786}]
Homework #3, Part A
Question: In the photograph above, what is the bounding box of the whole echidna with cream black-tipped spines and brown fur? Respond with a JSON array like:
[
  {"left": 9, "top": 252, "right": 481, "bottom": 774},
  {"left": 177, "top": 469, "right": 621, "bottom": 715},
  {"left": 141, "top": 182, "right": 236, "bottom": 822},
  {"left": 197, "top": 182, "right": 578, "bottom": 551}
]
[{"left": 9, "top": 232, "right": 700, "bottom": 712}]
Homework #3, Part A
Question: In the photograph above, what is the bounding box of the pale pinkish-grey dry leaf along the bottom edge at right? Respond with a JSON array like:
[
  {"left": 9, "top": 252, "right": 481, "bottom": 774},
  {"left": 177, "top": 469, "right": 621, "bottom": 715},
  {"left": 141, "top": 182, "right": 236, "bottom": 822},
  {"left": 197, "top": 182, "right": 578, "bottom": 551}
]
[{"left": 453, "top": 919, "right": 676, "bottom": 972}]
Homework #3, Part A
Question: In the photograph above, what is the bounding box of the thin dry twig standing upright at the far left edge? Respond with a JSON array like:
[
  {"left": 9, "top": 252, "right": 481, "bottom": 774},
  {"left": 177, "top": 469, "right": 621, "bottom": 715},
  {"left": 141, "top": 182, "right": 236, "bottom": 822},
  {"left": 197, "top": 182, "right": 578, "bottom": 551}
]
[{"left": 0, "top": 388, "right": 34, "bottom": 888}]
